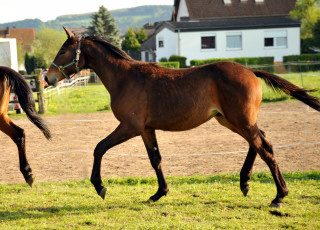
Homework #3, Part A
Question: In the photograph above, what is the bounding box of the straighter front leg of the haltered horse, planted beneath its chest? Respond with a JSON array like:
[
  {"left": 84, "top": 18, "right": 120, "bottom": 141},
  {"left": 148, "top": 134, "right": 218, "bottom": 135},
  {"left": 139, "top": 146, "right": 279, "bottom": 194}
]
[{"left": 141, "top": 129, "right": 169, "bottom": 202}]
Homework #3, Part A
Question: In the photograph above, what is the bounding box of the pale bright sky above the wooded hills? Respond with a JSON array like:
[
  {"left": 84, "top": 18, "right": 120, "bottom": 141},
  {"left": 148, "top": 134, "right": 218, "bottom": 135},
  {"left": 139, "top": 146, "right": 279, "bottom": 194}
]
[{"left": 0, "top": 0, "right": 174, "bottom": 23}]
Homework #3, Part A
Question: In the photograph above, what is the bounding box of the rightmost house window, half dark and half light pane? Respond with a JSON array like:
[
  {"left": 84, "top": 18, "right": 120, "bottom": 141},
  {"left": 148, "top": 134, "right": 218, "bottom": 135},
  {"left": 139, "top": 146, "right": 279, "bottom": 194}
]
[{"left": 264, "top": 30, "right": 288, "bottom": 48}]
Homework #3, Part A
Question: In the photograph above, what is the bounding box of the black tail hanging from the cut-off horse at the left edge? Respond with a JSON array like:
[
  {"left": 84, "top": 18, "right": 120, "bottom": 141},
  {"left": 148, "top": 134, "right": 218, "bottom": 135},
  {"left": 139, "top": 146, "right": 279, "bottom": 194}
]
[{"left": 0, "top": 67, "right": 51, "bottom": 139}]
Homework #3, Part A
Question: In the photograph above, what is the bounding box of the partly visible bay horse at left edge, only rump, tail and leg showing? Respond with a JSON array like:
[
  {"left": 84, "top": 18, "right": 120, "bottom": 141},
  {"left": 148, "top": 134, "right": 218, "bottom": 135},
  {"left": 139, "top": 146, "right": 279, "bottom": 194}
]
[{"left": 0, "top": 66, "right": 51, "bottom": 187}]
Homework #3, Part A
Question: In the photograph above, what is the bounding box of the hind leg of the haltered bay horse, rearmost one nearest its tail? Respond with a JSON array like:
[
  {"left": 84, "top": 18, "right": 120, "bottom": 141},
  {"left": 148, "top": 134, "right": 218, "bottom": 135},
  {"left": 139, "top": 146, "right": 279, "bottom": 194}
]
[{"left": 243, "top": 125, "right": 289, "bottom": 207}]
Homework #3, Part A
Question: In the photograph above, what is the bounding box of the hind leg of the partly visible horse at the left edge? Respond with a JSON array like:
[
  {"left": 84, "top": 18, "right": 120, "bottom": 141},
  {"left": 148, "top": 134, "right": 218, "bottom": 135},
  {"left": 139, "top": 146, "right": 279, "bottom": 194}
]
[{"left": 0, "top": 114, "right": 34, "bottom": 187}]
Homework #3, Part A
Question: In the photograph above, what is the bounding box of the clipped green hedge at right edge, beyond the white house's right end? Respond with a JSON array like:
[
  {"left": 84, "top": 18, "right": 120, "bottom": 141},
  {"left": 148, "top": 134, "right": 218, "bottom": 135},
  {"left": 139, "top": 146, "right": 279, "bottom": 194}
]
[{"left": 283, "top": 53, "right": 320, "bottom": 72}]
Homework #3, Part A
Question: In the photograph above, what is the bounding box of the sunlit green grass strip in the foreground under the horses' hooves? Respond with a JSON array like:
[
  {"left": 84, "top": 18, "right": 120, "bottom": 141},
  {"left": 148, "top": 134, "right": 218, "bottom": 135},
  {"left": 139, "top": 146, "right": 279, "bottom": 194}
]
[{"left": 0, "top": 172, "right": 320, "bottom": 229}]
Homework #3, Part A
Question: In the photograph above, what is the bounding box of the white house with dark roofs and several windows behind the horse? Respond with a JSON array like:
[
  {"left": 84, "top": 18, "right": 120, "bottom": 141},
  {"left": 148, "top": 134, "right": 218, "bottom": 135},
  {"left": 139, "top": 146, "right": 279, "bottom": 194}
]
[{"left": 141, "top": 0, "right": 300, "bottom": 65}]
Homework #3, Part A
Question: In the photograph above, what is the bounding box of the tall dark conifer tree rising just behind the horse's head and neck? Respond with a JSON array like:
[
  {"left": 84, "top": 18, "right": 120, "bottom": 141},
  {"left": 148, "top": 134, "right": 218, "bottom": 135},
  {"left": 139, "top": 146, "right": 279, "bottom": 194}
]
[{"left": 87, "top": 6, "right": 120, "bottom": 46}]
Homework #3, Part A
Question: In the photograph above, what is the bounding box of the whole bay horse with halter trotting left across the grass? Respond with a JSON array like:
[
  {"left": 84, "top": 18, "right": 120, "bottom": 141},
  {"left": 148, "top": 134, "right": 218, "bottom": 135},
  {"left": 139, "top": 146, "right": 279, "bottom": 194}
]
[{"left": 46, "top": 27, "right": 320, "bottom": 207}]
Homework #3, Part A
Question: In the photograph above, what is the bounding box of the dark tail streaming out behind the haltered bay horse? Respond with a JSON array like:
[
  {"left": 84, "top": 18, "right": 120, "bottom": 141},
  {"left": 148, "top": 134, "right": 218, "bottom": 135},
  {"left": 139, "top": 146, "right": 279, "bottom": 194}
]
[{"left": 252, "top": 70, "right": 320, "bottom": 112}]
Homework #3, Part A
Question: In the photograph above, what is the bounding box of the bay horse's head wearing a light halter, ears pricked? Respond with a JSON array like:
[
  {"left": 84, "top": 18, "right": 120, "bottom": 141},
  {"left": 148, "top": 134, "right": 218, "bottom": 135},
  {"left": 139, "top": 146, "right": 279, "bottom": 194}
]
[{"left": 45, "top": 27, "right": 84, "bottom": 85}]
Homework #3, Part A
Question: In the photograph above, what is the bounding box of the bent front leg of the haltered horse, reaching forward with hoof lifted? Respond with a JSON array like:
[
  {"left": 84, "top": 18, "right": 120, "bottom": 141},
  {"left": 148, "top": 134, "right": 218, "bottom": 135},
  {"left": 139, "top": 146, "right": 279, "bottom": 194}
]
[{"left": 90, "top": 123, "right": 139, "bottom": 199}]
